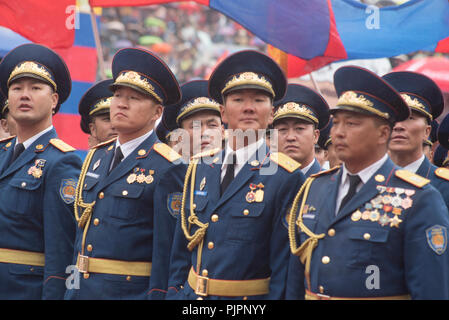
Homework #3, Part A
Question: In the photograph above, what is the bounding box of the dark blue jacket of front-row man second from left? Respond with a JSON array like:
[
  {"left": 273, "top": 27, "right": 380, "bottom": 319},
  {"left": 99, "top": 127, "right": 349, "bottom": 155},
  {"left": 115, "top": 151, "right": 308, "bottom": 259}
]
[{"left": 65, "top": 132, "right": 183, "bottom": 300}]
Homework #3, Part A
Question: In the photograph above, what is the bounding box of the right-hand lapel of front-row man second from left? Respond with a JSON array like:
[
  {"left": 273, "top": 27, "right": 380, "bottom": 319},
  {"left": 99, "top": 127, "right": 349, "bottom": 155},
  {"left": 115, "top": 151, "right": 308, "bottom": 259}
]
[{"left": 98, "top": 132, "right": 156, "bottom": 190}]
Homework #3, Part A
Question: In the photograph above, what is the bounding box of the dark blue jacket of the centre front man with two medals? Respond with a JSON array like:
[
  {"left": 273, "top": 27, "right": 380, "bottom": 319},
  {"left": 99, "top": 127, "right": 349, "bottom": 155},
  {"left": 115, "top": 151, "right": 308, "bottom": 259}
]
[{"left": 166, "top": 144, "right": 304, "bottom": 299}]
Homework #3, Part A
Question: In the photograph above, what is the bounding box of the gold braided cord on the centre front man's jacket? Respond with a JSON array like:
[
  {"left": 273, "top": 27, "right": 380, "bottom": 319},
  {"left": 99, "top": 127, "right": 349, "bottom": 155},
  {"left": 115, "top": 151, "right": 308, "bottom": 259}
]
[{"left": 181, "top": 159, "right": 209, "bottom": 251}]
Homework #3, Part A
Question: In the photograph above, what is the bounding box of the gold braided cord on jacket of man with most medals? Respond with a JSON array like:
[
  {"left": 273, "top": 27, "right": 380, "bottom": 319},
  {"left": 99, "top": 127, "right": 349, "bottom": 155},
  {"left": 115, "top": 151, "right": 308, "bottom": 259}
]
[{"left": 288, "top": 177, "right": 325, "bottom": 290}]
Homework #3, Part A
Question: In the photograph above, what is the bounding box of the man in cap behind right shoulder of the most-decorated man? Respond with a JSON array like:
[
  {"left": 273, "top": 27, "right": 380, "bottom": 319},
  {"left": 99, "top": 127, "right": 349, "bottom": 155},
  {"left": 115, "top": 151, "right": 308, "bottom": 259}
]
[{"left": 382, "top": 71, "right": 449, "bottom": 207}]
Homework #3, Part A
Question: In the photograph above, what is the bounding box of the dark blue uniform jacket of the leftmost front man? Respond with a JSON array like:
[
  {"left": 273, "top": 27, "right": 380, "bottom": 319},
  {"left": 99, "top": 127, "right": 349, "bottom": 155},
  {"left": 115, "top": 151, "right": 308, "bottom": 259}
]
[{"left": 0, "top": 129, "right": 81, "bottom": 299}]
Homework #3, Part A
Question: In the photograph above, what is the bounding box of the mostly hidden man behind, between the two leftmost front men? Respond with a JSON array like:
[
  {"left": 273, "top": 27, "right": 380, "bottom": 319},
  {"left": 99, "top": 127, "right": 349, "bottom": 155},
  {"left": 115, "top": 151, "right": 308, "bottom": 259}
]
[{"left": 78, "top": 79, "right": 117, "bottom": 147}]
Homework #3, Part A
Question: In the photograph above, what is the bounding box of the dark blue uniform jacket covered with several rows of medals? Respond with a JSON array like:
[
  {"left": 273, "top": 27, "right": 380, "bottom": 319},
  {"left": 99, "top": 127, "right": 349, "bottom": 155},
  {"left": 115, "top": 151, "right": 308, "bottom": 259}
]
[{"left": 287, "top": 159, "right": 449, "bottom": 299}]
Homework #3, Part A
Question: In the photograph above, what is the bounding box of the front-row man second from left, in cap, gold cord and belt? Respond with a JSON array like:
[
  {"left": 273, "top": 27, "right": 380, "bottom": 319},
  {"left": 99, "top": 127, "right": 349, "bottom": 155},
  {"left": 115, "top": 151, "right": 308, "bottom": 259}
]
[{"left": 65, "top": 48, "right": 183, "bottom": 299}]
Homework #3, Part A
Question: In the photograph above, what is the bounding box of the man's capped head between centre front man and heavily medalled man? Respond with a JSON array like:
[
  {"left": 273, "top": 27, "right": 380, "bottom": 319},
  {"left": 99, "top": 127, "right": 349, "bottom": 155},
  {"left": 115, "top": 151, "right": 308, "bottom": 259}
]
[{"left": 273, "top": 84, "right": 329, "bottom": 177}]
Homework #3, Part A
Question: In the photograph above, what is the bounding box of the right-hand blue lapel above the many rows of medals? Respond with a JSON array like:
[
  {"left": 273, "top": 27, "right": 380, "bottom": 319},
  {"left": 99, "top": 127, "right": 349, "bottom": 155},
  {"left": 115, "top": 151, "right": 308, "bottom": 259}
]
[{"left": 333, "top": 158, "right": 395, "bottom": 223}]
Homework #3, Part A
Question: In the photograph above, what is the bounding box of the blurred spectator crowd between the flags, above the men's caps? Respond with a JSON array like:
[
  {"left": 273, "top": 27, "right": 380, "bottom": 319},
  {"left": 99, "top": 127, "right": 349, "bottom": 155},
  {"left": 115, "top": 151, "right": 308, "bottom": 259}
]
[{"left": 100, "top": 2, "right": 266, "bottom": 83}]
